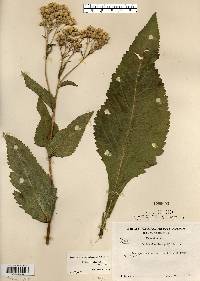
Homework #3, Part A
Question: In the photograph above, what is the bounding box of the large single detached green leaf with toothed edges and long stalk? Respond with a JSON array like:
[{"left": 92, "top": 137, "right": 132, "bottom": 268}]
[{"left": 94, "top": 14, "right": 170, "bottom": 238}]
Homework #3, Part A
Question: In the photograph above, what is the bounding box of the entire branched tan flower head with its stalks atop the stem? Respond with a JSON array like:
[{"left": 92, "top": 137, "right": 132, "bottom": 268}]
[{"left": 40, "top": 2, "right": 109, "bottom": 81}]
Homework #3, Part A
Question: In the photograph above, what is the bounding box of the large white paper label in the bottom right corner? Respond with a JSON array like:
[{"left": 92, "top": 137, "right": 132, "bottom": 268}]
[{"left": 112, "top": 222, "right": 200, "bottom": 281}]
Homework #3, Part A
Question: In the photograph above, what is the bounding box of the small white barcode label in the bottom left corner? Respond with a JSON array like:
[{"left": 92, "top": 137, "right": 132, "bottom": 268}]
[{"left": 0, "top": 264, "right": 34, "bottom": 277}]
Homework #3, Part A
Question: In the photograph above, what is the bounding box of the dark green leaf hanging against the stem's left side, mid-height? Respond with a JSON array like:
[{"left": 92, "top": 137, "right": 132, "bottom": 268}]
[{"left": 34, "top": 98, "right": 59, "bottom": 147}]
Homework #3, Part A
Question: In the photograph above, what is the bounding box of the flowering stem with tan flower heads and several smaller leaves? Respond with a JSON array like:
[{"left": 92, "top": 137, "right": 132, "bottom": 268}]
[{"left": 4, "top": 2, "right": 109, "bottom": 244}]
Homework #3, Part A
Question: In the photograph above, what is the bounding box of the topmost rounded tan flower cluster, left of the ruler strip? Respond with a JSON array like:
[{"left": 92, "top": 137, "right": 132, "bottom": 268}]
[{"left": 40, "top": 2, "right": 76, "bottom": 30}]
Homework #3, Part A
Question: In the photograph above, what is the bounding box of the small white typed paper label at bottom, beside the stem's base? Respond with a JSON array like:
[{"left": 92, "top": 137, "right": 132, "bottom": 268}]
[{"left": 67, "top": 251, "right": 111, "bottom": 275}]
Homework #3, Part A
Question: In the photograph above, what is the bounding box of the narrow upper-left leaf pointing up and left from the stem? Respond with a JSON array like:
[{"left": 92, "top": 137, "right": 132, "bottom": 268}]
[{"left": 22, "top": 72, "right": 55, "bottom": 110}]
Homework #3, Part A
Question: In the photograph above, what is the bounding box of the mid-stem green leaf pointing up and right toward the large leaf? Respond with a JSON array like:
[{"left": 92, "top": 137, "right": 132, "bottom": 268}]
[{"left": 47, "top": 112, "right": 93, "bottom": 157}]
